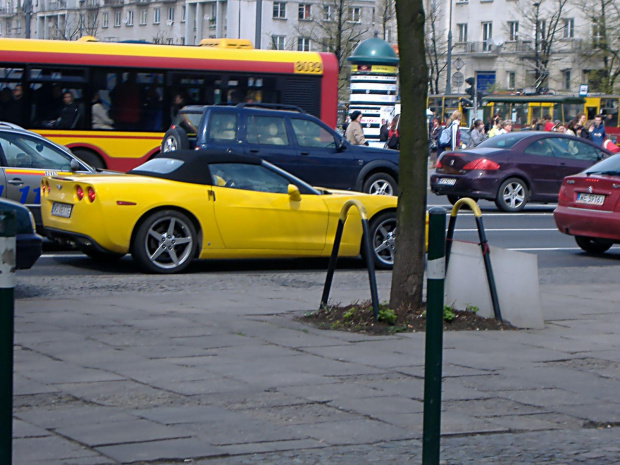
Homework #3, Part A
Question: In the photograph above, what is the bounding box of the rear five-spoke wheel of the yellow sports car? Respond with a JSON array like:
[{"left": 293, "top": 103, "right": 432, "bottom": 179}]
[{"left": 131, "top": 210, "right": 198, "bottom": 274}]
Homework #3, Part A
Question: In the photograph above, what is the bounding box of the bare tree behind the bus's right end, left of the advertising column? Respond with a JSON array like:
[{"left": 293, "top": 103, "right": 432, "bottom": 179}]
[{"left": 296, "top": 0, "right": 371, "bottom": 100}]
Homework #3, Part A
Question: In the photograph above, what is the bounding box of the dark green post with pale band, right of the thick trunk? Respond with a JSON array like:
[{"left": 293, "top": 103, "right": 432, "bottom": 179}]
[{"left": 422, "top": 207, "right": 446, "bottom": 465}]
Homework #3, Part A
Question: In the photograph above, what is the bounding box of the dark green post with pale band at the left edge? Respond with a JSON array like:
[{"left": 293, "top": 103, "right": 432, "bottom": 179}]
[{"left": 0, "top": 211, "right": 15, "bottom": 465}]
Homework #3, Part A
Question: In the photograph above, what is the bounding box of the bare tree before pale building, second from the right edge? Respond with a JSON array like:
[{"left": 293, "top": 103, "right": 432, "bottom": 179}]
[{"left": 515, "top": 0, "right": 569, "bottom": 89}]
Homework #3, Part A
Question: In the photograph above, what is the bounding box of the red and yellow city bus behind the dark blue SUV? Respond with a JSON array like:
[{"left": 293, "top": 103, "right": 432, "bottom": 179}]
[{"left": 0, "top": 38, "right": 338, "bottom": 171}]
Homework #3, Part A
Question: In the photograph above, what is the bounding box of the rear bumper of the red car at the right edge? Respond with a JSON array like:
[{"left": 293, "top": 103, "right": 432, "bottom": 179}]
[{"left": 553, "top": 207, "right": 620, "bottom": 241}]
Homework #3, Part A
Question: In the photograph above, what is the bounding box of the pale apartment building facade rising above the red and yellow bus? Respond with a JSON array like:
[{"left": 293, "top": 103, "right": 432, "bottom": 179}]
[{"left": 0, "top": 0, "right": 386, "bottom": 51}]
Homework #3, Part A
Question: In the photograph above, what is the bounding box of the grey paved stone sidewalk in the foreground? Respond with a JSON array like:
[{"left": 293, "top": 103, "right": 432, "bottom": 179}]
[{"left": 9, "top": 270, "right": 620, "bottom": 465}]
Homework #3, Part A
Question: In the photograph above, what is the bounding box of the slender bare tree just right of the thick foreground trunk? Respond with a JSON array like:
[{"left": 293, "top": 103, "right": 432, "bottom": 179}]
[{"left": 424, "top": 0, "right": 448, "bottom": 94}]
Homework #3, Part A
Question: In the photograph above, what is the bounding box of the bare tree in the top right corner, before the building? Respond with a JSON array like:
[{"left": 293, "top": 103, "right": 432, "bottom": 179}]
[{"left": 580, "top": 0, "right": 620, "bottom": 94}]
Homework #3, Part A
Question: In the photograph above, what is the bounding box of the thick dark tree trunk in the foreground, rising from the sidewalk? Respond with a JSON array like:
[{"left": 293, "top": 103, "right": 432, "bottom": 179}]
[{"left": 390, "top": 0, "right": 428, "bottom": 309}]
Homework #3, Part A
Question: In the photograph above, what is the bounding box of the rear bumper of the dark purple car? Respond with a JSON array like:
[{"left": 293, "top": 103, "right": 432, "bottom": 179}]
[{"left": 431, "top": 170, "right": 499, "bottom": 200}]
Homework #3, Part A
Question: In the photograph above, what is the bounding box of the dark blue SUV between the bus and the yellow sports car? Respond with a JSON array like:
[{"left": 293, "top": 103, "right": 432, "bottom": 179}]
[{"left": 161, "top": 103, "right": 398, "bottom": 195}]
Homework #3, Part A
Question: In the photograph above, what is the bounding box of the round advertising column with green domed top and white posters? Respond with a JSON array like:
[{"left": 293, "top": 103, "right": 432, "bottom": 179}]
[{"left": 347, "top": 38, "right": 398, "bottom": 147}]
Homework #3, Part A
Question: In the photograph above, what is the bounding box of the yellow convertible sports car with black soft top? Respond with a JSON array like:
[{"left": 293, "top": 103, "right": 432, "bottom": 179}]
[{"left": 41, "top": 150, "right": 397, "bottom": 273}]
